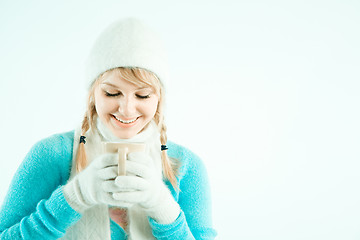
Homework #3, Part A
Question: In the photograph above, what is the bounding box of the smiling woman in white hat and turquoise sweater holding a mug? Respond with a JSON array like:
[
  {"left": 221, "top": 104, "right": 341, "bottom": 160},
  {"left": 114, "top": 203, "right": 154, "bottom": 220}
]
[{"left": 0, "top": 19, "right": 216, "bottom": 240}]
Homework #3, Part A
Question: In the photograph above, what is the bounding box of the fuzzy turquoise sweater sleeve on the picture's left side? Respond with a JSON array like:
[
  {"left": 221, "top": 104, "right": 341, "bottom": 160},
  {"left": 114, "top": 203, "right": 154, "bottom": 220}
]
[{"left": 0, "top": 132, "right": 80, "bottom": 239}]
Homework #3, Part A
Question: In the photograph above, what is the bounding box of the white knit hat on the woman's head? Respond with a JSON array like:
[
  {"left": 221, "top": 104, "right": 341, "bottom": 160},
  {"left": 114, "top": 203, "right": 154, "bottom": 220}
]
[{"left": 85, "top": 18, "right": 168, "bottom": 86}]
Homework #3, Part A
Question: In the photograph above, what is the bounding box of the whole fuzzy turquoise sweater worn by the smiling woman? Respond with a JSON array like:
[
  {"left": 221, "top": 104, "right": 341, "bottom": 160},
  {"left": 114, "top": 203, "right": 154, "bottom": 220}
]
[{"left": 0, "top": 131, "right": 216, "bottom": 240}]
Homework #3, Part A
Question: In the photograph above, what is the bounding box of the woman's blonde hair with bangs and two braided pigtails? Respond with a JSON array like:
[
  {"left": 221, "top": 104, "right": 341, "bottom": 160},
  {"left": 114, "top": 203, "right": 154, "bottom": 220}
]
[{"left": 75, "top": 67, "right": 178, "bottom": 189}]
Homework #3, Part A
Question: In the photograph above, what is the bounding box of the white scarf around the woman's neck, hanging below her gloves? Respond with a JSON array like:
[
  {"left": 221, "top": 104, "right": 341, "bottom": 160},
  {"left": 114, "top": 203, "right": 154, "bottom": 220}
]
[{"left": 61, "top": 119, "right": 162, "bottom": 240}]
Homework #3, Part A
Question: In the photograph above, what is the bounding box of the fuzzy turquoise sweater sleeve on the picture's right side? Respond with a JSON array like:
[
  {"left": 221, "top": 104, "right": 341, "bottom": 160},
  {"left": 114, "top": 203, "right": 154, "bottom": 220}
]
[{"left": 150, "top": 142, "right": 217, "bottom": 240}]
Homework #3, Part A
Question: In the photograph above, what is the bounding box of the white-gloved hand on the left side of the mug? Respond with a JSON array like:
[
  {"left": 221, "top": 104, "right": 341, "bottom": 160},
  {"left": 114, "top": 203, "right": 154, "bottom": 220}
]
[{"left": 63, "top": 153, "right": 131, "bottom": 213}]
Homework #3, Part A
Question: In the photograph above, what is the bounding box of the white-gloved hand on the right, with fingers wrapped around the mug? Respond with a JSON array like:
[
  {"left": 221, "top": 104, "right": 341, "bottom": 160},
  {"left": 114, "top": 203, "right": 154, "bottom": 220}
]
[{"left": 113, "top": 152, "right": 180, "bottom": 224}]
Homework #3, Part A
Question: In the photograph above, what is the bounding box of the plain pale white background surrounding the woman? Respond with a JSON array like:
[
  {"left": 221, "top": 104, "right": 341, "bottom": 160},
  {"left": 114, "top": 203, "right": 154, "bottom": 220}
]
[{"left": 0, "top": 0, "right": 360, "bottom": 240}]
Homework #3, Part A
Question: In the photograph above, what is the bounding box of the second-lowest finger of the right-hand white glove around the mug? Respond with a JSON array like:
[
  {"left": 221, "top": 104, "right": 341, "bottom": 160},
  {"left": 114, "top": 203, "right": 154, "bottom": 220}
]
[{"left": 115, "top": 176, "right": 150, "bottom": 192}]
